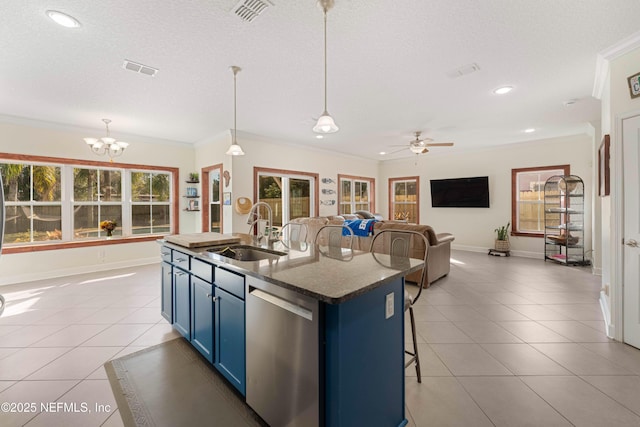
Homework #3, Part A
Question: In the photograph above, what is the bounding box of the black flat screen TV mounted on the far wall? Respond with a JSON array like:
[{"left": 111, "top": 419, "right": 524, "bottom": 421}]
[{"left": 431, "top": 176, "right": 489, "bottom": 208}]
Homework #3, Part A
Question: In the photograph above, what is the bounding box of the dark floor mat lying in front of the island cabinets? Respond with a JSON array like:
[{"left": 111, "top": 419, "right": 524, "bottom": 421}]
[{"left": 105, "top": 338, "right": 266, "bottom": 427}]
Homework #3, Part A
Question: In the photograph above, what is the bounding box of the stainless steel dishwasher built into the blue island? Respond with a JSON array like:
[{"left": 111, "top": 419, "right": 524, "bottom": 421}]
[{"left": 246, "top": 276, "right": 320, "bottom": 427}]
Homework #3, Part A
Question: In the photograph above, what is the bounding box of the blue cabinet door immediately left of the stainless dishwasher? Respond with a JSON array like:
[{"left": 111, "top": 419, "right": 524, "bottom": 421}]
[{"left": 214, "top": 287, "right": 246, "bottom": 396}]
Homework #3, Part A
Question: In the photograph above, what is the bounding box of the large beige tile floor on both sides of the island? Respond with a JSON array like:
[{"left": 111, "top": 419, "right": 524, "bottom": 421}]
[{"left": 0, "top": 251, "right": 640, "bottom": 427}]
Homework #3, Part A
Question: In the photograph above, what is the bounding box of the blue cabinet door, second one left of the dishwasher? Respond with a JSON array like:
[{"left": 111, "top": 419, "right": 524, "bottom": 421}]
[{"left": 191, "top": 276, "right": 214, "bottom": 363}]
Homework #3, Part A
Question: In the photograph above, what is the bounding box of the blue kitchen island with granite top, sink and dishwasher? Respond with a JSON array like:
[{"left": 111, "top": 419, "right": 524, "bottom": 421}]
[{"left": 161, "top": 236, "right": 423, "bottom": 427}]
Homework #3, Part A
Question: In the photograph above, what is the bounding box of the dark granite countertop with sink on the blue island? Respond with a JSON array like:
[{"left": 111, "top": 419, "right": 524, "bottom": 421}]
[{"left": 160, "top": 234, "right": 424, "bottom": 304}]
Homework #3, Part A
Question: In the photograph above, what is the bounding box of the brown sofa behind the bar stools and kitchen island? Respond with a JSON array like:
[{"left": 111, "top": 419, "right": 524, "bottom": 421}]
[{"left": 291, "top": 215, "right": 455, "bottom": 287}]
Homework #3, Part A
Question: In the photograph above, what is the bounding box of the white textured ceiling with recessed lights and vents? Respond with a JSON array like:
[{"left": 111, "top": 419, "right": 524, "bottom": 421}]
[{"left": 0, "top": 0, "right": 640, "bottom": 159}]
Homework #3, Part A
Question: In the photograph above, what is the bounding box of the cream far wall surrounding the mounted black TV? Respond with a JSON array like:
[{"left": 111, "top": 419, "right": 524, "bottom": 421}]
[{"left": 378, "top": 134, "right": 593, "bottom": 259}]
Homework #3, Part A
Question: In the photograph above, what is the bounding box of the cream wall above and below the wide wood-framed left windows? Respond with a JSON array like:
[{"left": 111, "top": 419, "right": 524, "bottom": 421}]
[{"left": 0, "top": 118, "right": 195, "bottom": 285}]
